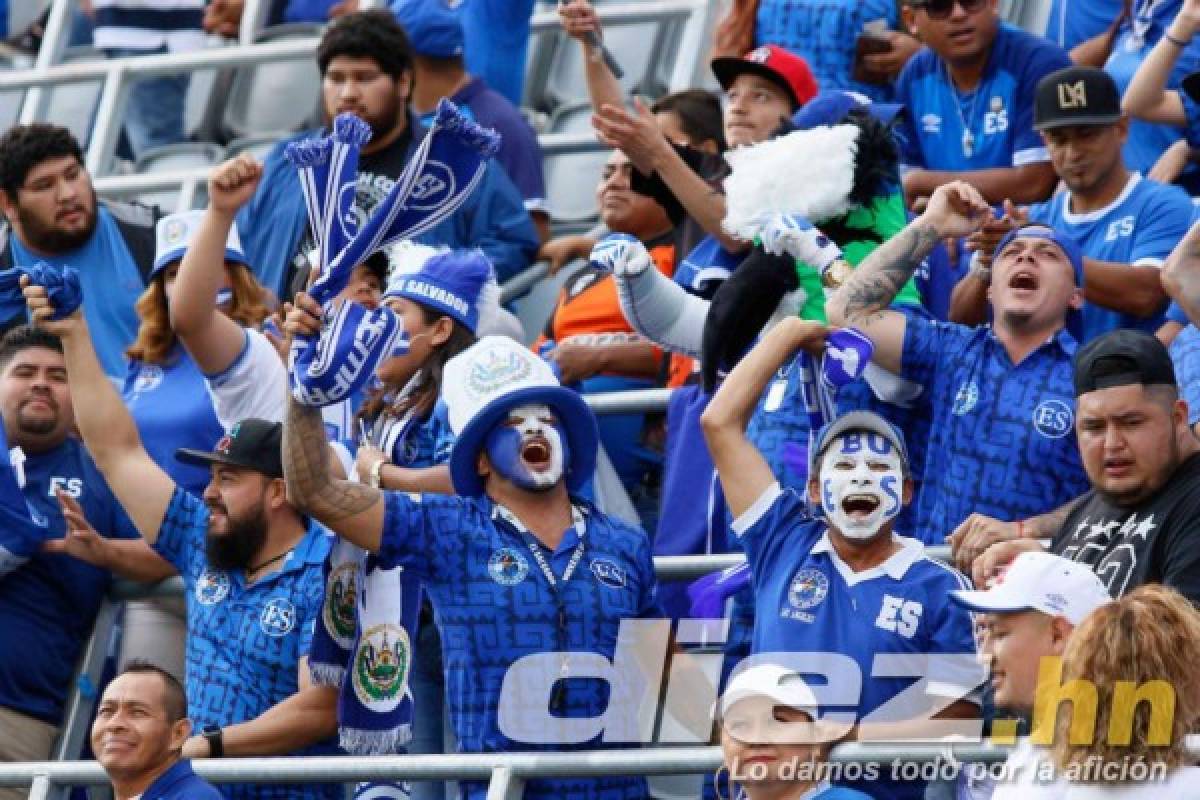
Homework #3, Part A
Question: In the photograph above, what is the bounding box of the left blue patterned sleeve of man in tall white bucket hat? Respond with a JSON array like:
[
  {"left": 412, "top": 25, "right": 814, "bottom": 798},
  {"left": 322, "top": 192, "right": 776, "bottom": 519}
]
[{"left": 378, "top": 492, "right": 472, "bottom": 582}]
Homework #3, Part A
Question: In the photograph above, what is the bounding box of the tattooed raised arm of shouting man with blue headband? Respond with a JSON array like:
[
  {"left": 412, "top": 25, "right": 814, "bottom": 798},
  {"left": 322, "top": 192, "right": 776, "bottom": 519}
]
[{"left": 826, "top": 181, "right": 991, "bottom": 373}]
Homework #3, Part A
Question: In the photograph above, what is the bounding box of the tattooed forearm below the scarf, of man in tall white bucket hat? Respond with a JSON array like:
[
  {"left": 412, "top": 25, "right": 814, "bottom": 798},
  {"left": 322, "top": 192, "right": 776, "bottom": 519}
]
[{"left": 283, "top": 396, "right": 383, "bottom": 525}]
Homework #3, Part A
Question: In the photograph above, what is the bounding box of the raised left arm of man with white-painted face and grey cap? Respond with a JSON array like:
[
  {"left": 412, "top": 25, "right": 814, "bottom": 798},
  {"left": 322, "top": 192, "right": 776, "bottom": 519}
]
[{"left": 700, "top": 317, "right": 826, "bottom": 519}]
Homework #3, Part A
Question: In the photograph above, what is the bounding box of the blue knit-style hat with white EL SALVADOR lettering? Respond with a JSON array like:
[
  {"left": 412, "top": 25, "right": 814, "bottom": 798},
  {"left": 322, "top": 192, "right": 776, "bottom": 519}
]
[{"left": 383, "top": 249, "right": 492, "bottom": 333}]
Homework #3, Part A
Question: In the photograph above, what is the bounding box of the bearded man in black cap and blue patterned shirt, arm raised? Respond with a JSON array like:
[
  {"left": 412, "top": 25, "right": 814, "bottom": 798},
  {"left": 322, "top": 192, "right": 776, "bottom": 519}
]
[{"left": 23, "top": 281, "right": 341, "bottom": 800}]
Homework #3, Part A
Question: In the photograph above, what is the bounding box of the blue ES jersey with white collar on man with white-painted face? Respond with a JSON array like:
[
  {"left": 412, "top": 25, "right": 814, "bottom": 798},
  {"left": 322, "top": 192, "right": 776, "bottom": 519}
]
[{"left": 733, "top": 483, "right": 985, "bottom": 800}]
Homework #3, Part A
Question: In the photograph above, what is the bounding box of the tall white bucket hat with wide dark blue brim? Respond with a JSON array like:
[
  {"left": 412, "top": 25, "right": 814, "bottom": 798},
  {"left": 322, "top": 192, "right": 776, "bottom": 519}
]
[{"left": 442, "top": 336, "right": 600, "bottom": 497}]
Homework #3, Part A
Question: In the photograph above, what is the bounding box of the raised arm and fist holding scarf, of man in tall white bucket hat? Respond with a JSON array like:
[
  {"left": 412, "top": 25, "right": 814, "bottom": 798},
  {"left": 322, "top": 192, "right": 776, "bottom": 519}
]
[{"left": 283, "top": 293, "right": 384, "bottom": 552}]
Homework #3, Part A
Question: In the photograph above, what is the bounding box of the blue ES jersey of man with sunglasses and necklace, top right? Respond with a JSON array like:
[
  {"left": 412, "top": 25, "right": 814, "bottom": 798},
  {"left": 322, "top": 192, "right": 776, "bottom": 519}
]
[{"left": 896, "top": 24, "right": 1070, "bottom": 172}]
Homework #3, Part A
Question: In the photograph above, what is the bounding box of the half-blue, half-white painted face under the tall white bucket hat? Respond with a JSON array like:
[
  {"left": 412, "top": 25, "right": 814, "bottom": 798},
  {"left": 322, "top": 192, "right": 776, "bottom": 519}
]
[{"left": 484, "top": 405, "right": 569, "bottom": 492}]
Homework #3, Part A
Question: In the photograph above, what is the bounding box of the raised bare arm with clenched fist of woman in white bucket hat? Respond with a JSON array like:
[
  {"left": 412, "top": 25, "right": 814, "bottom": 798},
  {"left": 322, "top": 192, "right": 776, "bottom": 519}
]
[{"left": 170, "top": 155, "right": 263, "bottom": 375}]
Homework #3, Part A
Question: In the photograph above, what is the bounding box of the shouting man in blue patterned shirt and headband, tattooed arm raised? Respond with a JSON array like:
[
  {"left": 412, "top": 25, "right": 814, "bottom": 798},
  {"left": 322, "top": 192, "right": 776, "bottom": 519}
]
[{"left": 826, "top": 181, "right": 1087, "bottom": 542}]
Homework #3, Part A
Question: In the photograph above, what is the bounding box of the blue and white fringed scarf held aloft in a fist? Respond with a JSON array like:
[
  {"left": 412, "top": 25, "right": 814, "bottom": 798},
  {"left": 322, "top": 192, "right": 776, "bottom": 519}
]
[{"left": 284, "top": 100, "right": 499, "bottom": 405}]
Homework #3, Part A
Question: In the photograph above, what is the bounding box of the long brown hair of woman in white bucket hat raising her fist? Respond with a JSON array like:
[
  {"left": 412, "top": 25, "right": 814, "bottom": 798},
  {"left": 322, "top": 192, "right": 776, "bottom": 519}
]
[{"left": 125, "top": 264, "right": 270, "bottom": 365}]
